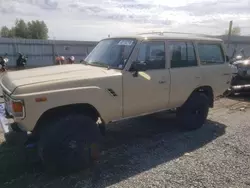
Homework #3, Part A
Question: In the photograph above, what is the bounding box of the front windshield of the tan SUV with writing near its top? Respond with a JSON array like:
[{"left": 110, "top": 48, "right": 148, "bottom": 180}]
[{"left": 84, "top": 39, "right": 136, "bottom": 69}]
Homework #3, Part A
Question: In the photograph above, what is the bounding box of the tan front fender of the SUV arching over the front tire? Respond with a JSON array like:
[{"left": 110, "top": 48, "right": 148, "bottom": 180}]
[{"left": 13, "top": 86, "right": 122, "bottom": 130}]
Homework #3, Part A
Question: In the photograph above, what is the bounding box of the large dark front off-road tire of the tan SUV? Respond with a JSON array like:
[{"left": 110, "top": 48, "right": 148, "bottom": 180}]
[{"left": 38, "top": 115, "right": 101, "bottom": 174}]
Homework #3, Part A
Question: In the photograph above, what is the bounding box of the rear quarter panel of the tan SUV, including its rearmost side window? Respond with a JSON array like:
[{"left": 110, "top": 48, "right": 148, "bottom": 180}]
[{"left": 197, "top": 41, "right": 232, "bottom": 97}]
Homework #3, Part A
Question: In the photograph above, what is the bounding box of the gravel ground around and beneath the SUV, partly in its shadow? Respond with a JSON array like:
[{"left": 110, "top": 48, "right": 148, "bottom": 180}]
[{"left": 0, "top": 96, "right": 250, "bottom": 188}]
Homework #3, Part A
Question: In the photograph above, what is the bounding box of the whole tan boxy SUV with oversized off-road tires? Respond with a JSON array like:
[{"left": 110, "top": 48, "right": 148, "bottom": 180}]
[{"left": 1, "top": 33, "right": 231, "bottom": 171}]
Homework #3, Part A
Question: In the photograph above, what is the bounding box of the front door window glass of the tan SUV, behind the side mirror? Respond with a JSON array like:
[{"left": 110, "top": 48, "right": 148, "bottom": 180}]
[{"left": 137, "top": 41, "right": 166, "bottom": 70}]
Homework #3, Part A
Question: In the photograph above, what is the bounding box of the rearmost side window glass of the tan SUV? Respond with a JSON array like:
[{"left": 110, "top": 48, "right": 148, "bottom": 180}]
[{"left": 197, "top": 43, "right": 225, "bottom": 65}]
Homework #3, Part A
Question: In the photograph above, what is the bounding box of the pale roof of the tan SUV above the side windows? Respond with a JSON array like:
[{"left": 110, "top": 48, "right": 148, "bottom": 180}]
[{"left": 107, "top": 32, "right": 223, "bottom": 42}]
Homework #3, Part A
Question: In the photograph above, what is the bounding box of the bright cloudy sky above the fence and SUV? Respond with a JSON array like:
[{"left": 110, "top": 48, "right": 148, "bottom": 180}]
[{"left": 0, "top": 0, "right": 250, "bottom": 40}]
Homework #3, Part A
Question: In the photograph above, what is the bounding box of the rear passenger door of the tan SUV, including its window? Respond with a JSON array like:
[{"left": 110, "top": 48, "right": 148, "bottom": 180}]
[{"left": 167, "top": 40, "right": 202, "bottom": 108}]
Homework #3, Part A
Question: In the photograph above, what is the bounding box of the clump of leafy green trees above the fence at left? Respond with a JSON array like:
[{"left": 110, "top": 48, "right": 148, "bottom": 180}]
[{"left": 0, "top": 19, "right": 49, "bottom": 39}]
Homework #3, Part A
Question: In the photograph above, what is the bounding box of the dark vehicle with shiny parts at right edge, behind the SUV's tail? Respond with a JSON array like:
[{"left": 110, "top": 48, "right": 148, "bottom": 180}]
[{"left": 229, "top": 50, "right": 250, "bottom": 94}]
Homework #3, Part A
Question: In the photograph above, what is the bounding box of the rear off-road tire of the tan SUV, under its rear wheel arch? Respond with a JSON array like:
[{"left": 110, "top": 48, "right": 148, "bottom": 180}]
[{"left": 177, "top": 92, "right": 209, "bottom": 131}]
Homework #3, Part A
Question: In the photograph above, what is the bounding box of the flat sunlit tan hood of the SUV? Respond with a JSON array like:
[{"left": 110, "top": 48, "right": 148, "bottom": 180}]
[{"left": 1, "top": 64, "right": 119, "bottom": 93}]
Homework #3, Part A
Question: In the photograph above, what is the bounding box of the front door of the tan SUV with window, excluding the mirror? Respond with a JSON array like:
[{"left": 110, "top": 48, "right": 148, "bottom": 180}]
[{"left": 123, "top": 41, "right": 170, "bottom": 117}]
